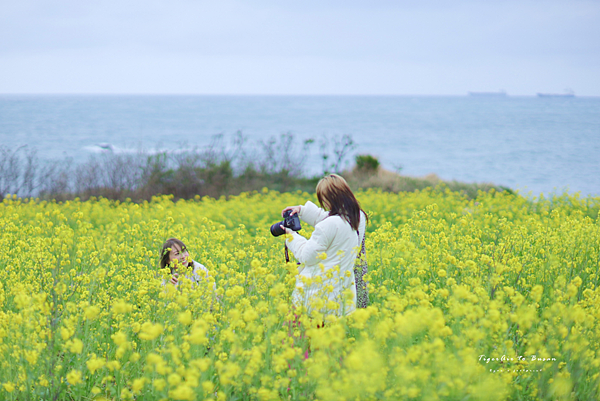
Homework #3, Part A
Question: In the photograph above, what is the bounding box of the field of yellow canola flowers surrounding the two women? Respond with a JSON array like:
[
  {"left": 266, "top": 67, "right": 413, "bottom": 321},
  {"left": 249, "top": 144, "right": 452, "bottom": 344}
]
[{"left": 0, "top": 189, "right": 600, "bottom": 400}]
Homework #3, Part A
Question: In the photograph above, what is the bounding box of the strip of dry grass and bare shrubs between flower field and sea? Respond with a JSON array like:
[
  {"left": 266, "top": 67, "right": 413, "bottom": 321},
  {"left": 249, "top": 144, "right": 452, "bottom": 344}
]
[{"left": 0, "top": 134, "right": 512, "bottom": 201}]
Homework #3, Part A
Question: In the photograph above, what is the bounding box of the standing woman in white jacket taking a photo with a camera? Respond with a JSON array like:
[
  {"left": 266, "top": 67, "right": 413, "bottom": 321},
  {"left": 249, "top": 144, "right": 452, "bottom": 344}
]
[{"left": 281, "top": 174, "right": 368, "bottom": 316}]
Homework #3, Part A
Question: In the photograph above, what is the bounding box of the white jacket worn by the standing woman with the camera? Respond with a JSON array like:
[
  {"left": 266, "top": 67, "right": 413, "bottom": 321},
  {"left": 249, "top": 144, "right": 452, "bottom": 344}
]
[{"left": 286, "top": 201, "right": 366, "bottom": 316}]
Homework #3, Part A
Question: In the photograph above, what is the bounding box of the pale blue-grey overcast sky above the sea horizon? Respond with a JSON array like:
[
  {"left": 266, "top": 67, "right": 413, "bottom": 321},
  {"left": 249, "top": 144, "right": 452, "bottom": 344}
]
[{"left": 0, "top": 0, "right": 600, "bottom": 96}]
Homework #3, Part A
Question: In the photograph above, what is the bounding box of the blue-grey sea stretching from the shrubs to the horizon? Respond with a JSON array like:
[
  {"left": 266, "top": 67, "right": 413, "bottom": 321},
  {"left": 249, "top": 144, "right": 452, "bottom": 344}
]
[{"left": 0, "top": 95, "right": 600, "bottom": 196}]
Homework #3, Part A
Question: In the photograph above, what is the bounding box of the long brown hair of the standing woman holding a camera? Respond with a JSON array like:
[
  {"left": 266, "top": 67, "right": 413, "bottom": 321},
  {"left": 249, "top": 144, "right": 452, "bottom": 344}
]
[{"left": 317, "top": 174, "right": 369, "bottom": 230}]
